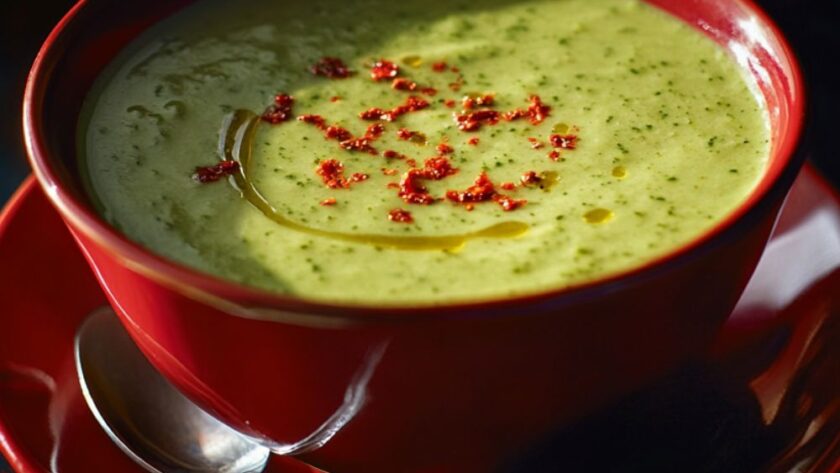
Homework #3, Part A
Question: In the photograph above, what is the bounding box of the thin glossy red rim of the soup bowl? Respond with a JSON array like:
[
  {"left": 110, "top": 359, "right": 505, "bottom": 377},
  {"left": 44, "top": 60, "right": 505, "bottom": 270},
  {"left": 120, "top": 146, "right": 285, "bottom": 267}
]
[{"left": 23, "top": 0, "right": 807, "bottom": 322}]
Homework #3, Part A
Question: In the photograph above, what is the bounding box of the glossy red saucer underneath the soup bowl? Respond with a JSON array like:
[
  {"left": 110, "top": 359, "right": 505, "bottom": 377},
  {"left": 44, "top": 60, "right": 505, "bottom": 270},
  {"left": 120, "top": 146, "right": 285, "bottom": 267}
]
[{"left": 0, "top": 163, "right": 840, "bottom": 473}]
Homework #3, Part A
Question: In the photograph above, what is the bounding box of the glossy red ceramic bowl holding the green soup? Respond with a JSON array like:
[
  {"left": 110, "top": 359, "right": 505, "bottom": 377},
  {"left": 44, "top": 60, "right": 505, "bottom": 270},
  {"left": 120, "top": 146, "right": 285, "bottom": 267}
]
[{"left": 23, "top": 0, "right": 805, "bottom": 473}]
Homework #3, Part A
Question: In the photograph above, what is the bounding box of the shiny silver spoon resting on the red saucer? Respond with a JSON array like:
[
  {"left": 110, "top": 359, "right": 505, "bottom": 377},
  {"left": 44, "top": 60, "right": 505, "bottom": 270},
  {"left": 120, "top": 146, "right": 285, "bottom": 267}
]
[{"left": 75, "top": 308, "right": 270, "bottom": 473}]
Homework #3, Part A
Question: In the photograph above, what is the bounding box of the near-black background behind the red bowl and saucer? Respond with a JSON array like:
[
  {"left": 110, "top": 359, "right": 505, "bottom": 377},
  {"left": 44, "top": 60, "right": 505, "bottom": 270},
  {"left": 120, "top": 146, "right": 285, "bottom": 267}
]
[{"left": 0, "top": 0, "right": 840, "bottom": 473}]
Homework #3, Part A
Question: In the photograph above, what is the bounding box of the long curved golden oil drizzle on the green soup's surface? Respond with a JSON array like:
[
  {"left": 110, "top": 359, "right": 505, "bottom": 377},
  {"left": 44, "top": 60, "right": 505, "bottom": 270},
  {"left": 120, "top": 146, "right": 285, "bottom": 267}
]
[{"left": 219, "top": 110, "right": 529, "bottom": 251}]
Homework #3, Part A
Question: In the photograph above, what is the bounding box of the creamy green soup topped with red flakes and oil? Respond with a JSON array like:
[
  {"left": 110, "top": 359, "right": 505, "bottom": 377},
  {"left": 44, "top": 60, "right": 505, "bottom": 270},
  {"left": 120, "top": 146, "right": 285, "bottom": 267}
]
[{"left": 80, "top": 0, "right": 769, "bottom": 304}]
